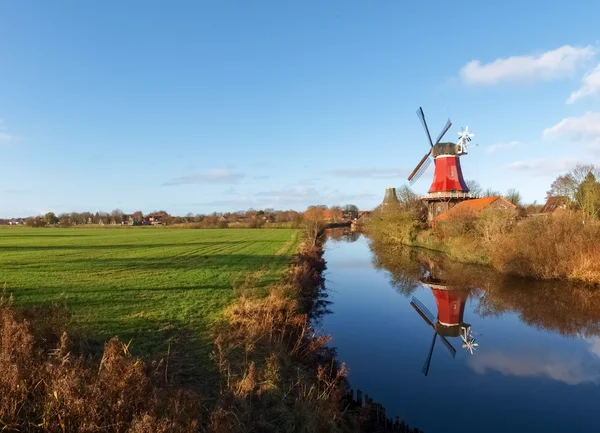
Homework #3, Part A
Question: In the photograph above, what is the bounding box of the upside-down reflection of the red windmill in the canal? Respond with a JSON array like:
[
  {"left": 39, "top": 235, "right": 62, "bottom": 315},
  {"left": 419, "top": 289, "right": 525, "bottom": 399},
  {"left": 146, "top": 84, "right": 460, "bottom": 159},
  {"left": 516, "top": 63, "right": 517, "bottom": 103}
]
[{"left": 410, "top": 264, "right": 478, "bottom": 376}]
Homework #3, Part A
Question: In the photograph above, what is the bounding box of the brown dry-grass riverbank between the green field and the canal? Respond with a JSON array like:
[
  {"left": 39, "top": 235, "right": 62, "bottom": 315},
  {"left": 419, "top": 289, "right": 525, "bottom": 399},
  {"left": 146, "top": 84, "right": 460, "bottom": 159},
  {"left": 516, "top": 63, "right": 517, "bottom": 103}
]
[{"left": 0, "top": 228, "right": 416, "bottom": 433}]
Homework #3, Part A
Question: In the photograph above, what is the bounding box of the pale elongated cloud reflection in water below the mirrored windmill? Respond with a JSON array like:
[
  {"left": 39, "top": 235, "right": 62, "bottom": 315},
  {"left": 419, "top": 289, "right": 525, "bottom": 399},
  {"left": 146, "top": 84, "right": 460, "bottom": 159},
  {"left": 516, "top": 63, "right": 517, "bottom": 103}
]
[{"left": 469, "top": 350, "right": 600, "bottom": 385}]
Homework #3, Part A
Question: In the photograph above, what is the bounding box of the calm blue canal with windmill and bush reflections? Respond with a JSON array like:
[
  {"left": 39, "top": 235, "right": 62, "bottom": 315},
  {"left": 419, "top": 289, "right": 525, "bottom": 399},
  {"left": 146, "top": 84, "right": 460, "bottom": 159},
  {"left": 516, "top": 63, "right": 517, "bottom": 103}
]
[{"left": 319, "top": 231, "right": 600, "bottom": 433}]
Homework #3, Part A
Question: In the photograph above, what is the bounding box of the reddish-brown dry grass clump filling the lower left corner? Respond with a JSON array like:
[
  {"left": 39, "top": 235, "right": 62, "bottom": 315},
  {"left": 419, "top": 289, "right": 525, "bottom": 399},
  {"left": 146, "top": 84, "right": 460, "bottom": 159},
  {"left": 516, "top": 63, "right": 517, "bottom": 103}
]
[{"left": 0, "top": 284, "right": 201, "bottom": 432}]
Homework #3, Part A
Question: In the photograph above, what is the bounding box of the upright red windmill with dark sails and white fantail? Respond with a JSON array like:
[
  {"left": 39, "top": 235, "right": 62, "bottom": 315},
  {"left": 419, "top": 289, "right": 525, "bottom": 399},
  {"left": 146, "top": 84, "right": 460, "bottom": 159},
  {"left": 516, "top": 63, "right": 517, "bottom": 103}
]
[{"left": 408, "top": 107, "right": 474, "bottom": 221}]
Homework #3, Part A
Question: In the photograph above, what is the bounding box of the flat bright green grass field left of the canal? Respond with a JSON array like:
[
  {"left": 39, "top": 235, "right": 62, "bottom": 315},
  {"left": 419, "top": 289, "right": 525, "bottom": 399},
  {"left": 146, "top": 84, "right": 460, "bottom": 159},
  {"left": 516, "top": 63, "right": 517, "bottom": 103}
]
[{"left": 0, "top": 227, "right": 300, "bottom": 362}]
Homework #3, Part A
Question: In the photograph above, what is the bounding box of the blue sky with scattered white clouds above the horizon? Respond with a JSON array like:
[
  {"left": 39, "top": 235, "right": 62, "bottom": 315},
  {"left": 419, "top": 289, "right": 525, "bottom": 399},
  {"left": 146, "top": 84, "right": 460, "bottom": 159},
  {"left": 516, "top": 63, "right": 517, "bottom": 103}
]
[{"left": 0, "top": 0, "right": 600, "bottom": 217}]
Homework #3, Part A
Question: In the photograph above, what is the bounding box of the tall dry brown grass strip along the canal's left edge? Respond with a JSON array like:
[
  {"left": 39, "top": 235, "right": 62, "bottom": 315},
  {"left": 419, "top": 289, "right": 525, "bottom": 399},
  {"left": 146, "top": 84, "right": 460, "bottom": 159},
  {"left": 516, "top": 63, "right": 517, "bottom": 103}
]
[{"left": 211, "top": 243, "right": 358, "bottom": 433}]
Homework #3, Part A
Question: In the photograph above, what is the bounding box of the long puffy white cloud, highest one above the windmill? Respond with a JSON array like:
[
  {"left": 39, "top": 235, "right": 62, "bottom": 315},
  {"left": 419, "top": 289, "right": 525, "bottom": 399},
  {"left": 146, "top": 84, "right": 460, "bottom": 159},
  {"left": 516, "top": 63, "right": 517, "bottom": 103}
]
[{"left": 460, "top": 45, "right": 594, "bottom": 85}]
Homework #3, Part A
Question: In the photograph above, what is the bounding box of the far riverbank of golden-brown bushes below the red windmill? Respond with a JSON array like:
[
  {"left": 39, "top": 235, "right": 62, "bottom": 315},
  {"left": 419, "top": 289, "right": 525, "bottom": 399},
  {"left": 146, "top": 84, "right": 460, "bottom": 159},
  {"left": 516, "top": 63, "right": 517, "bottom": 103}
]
[{"left": 365, "top": 209, "right": 600, "bottom": 285}]
